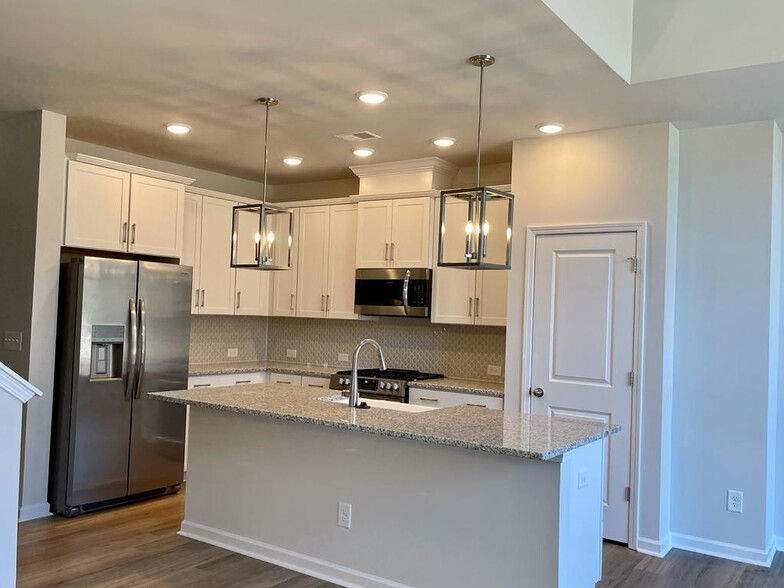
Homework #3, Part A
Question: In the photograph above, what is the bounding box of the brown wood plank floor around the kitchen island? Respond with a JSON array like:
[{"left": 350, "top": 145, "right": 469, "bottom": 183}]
[{"left": 18, "top": 493, "right": 784, "bottom": 588}]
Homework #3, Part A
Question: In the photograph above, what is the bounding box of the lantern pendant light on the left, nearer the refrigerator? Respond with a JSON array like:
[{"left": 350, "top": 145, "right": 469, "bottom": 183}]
[{"left": 231, "top": 98, "right": 294, "bottom": 270}]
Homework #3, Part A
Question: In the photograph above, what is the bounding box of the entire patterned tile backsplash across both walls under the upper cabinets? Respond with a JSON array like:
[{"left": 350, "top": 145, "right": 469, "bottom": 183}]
[{"left": 191, "top": 316, "right": 506, "bottom": 381}]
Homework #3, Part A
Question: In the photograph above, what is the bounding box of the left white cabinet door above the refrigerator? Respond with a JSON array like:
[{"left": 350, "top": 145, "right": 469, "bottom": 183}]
[{"left": 64, "top": 161, "right": 131, "bottom": 251}]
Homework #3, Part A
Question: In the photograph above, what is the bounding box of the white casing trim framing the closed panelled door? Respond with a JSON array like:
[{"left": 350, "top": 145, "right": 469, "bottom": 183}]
[{"left": 520, "top": 221, "right": 648, "bottom": 550}]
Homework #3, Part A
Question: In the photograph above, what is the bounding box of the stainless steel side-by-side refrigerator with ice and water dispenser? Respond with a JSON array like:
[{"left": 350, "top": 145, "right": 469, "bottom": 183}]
[{"left": 49, "top": 257, "right": 192, "bottom": 516}]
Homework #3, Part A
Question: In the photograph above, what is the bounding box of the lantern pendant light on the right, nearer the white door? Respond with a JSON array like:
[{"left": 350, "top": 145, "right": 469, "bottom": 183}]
[{"left": 438, "top": 55, "right": 514, "bottom": 270}]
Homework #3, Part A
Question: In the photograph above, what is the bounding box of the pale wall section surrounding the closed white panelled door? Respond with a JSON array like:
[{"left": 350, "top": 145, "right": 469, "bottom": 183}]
[{"left": 505, "top": 123, "right": 678, "bottom": 549}]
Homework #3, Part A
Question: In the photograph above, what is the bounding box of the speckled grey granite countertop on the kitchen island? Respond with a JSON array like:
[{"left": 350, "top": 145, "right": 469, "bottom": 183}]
[{"left": 150, "top": 384, "right": 620, "bottom": 460}]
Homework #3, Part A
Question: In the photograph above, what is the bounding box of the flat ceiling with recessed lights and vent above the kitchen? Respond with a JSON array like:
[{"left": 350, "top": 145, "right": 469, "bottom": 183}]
[{"left": 0, "top": 0, "right": 784, "bottom": 183}]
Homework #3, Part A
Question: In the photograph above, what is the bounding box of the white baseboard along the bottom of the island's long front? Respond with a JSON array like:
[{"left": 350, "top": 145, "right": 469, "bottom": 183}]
[{"left": 178, "top": 521, "right": 411, "bottom": 588}]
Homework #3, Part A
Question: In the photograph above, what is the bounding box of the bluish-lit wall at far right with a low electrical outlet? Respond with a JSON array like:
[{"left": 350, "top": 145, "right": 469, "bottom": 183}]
[{"left": 672, "top": 121, "right": 781, "bottom": 563}]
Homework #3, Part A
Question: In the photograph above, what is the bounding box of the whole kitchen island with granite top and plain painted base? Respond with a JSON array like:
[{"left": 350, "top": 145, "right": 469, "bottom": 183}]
[{"left": 152, "top": 384, "right": 618, "bottom": 588}]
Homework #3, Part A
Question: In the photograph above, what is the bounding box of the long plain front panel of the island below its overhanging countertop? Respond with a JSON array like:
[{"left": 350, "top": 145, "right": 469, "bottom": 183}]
[{"left": 182, "top": 407, "right": 562, "bottom": 588}]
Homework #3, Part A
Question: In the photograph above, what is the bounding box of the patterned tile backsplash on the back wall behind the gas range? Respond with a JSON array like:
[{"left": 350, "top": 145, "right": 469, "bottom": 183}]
[{"left": 266, "top": 317, "right": 506, "bottom": 382}]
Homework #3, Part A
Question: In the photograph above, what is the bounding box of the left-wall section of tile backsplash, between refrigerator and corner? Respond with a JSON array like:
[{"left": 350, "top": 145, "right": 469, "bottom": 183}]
[{"left": 190, "top": 315, "right": 270, "bottom": 363}]
